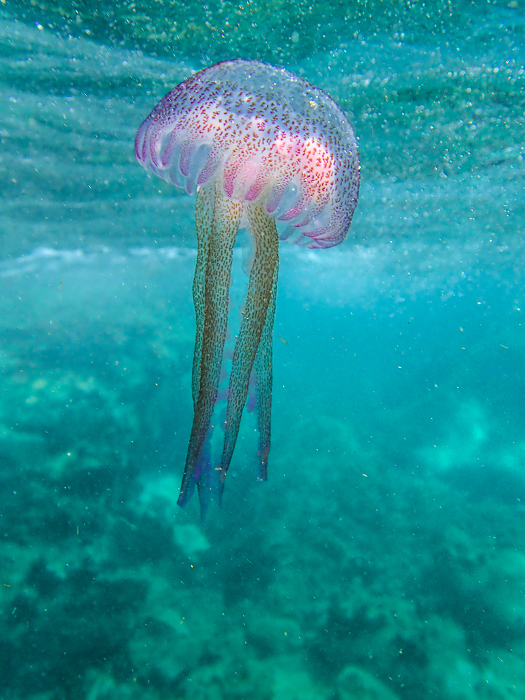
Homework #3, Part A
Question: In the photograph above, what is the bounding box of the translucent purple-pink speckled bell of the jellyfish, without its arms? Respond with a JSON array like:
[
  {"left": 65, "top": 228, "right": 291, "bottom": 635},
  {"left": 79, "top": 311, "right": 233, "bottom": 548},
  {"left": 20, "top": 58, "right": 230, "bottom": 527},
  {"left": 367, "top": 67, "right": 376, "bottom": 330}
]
[{"left": 135, "top": 60, "right": 359, "bottom": 248}]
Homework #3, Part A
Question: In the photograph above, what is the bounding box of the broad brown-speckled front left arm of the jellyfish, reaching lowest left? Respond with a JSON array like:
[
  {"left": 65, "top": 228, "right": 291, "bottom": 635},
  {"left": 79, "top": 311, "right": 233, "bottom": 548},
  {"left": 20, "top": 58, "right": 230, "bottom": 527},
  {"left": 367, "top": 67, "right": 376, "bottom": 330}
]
[{"left": 177, "top": 184, "right": 242, "bottom": 509}]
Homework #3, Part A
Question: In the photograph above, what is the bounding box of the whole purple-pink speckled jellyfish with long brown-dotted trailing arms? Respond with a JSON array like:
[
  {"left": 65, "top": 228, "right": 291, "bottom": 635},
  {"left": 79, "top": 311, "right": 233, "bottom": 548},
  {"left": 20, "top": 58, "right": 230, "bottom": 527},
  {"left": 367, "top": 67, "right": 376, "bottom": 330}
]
[{"left": 135, "top": 59, "right": 360, "bottom": 516}]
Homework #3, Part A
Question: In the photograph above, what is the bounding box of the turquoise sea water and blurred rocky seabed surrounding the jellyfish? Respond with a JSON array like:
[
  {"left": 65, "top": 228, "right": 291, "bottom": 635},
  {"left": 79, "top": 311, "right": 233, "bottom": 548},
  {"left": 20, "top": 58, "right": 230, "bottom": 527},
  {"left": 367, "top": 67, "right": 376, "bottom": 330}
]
[{"left": 0, "top": 0, "right": 525, "bottom": 700}]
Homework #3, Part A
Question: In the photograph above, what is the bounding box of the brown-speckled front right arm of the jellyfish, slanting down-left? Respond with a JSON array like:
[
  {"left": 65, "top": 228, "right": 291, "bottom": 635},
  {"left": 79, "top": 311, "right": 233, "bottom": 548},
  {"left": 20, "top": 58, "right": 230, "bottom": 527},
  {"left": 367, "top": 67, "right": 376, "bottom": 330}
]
[{"left": 219, "top": 203, "right": 279, "bottom": 500}]
